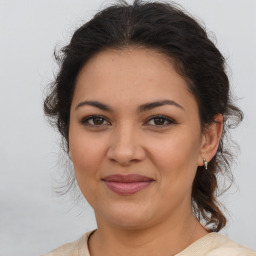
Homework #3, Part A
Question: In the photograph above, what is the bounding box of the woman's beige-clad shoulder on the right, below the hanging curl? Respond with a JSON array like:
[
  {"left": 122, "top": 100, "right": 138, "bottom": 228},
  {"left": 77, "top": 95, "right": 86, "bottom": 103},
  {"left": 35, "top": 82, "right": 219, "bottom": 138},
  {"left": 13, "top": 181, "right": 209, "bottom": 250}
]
[{"left": 176, "top": 232, "right": 256, "bottom": 256}]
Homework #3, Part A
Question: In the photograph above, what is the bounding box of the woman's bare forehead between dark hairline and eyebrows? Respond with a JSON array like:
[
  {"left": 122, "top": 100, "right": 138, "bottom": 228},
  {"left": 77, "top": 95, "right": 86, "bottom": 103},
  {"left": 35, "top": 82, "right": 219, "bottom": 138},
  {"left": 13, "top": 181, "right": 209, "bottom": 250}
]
[{"left": 73, "top": 48, "right": 198, "bottom": 113}]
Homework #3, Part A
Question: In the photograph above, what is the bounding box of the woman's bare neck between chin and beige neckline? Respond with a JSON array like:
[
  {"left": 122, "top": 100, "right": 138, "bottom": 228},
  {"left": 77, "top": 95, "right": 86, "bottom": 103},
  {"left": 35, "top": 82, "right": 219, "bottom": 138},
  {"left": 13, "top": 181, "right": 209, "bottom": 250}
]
[{"left": 89, "top": 213, "right": 207, "bottom": 256}]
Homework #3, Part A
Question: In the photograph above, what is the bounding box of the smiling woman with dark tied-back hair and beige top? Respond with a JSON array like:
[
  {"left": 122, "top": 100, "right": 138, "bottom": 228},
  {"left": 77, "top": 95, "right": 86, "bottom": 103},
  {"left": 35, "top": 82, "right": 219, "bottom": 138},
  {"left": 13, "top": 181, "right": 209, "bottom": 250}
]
[{"left": 44, "top": 1, "right": 256, "bottom": 256}]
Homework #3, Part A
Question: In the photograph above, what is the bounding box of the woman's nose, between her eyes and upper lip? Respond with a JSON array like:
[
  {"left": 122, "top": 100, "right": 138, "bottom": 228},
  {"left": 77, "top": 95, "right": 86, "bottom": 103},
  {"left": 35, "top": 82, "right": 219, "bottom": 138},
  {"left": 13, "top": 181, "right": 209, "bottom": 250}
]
[{"left": 107, "top": 125, "right": 146, "bottom": 166}]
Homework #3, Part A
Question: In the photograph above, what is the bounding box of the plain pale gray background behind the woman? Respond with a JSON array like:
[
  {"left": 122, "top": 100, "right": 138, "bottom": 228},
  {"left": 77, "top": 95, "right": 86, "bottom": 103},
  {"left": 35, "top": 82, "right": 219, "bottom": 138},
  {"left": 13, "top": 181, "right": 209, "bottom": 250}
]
[{"left": 0, "top": 0, "right": 256, "bottom": 256}]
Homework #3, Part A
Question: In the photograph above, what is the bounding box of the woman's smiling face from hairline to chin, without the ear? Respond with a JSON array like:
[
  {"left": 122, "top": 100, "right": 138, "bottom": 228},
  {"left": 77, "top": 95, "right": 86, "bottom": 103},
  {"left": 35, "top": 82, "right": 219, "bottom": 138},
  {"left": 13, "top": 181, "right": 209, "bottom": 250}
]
[{"left": 69, "top": 49, "right": 203, "bottom": 229}]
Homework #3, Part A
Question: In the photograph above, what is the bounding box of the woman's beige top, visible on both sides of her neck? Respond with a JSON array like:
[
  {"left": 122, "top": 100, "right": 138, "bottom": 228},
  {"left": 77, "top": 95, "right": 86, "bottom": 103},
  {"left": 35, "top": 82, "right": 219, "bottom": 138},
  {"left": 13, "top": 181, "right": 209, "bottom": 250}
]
[{"left": 42, "top": 231, "right": 256, "bottom": 256}]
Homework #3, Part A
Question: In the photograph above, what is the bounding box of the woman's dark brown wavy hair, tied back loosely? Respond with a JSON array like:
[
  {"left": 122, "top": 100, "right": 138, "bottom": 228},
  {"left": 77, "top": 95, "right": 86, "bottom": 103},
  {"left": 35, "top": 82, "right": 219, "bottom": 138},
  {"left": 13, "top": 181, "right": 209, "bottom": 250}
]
[{"left": 44, "top": 0, "right": 243, "bottom": 231}]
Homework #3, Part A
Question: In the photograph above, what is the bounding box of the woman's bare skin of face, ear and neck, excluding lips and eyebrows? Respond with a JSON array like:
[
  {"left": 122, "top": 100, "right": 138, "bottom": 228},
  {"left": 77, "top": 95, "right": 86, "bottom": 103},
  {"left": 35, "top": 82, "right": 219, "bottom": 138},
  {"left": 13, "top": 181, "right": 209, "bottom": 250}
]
[{"left": 69, "top": 48, "right": 222, "bottom": 256}]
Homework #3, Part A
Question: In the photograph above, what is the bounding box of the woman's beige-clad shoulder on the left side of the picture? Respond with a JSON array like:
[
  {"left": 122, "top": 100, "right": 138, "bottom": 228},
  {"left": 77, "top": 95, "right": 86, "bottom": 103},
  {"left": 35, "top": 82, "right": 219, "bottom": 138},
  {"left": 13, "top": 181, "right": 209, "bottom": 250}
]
[{"left": 41, "top": 231, "right": 93, "bottom": 256}]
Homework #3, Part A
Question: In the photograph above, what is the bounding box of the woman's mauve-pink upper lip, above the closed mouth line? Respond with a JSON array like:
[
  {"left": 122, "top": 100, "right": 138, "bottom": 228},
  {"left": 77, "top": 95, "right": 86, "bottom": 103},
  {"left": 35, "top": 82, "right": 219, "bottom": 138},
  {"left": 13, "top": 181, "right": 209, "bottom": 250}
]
[{"left": 102, "top": 174, "right": 154, "bottom": 183}]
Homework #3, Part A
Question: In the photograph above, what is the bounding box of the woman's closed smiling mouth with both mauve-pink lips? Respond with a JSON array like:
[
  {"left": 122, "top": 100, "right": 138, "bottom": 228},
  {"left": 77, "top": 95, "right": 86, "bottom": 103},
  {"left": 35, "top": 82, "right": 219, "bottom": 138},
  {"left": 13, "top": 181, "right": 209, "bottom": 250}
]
[{"left": 102, "top": 174, "right": 154, "bottom": 195}]
